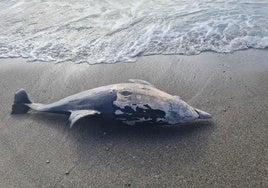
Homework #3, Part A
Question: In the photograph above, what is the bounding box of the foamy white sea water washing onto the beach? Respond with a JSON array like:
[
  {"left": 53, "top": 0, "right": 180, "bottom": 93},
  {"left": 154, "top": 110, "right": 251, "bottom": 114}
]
[{"left": 0, "top": 0, "right": 268, "bottom": 64}]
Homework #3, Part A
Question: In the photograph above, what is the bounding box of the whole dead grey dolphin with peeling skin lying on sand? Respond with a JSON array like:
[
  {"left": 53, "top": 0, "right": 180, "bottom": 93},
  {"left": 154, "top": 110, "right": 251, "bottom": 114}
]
[{"left": 11, "top": 79, "right": 211, "bottom": 127}]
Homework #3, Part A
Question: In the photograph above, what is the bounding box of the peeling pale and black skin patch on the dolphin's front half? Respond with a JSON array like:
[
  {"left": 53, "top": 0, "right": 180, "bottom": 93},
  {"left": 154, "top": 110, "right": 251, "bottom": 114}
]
[{"left": 113, "top": 84, "right": 198, "bottom": 124}]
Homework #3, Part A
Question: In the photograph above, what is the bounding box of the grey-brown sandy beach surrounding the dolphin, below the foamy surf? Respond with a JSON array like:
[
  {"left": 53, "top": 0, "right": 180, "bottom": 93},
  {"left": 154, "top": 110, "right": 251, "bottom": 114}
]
[{"left": 0, "top": 50, "right": 268, "bottom": 188}]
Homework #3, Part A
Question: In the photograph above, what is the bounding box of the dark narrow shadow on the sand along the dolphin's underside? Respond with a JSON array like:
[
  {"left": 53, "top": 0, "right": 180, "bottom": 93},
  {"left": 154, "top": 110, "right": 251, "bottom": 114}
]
[{"left": 22, "top": 113, "right": 214, "bottom": 139}]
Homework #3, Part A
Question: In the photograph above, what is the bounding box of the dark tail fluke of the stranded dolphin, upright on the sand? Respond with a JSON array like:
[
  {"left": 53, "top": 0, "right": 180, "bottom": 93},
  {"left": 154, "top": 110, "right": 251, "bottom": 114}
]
[{"left": 11, "top": 89, "right": 32, "bottom": 114}]
